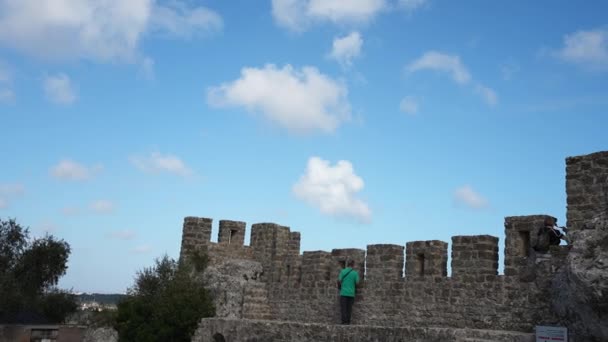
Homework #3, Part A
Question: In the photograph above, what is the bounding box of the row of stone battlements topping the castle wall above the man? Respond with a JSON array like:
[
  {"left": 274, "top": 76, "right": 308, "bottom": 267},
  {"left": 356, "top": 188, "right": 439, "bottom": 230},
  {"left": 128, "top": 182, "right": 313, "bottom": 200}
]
[{"left": 181, "top": 215, "right": 552, "bottom": 287}]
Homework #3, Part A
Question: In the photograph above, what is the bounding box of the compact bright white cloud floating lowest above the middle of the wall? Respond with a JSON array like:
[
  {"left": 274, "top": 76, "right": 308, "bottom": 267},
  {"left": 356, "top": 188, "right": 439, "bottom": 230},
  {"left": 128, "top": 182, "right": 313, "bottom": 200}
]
[{"left": 292, "top": 157, "right": 372, "bottom": 222}]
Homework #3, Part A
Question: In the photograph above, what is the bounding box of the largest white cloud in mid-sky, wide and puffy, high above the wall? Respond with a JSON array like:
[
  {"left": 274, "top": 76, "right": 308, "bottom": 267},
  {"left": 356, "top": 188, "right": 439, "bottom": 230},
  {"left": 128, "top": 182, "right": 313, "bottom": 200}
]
[{"left": 207, "top": 64, "right": 351, "bottom": 134}]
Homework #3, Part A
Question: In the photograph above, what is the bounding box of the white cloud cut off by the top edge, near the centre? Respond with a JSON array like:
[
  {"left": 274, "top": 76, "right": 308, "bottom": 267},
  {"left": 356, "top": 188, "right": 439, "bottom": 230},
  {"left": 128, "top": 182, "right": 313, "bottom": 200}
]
[{"left": 272, "top": 0, "right": 388, "bottom": 31}]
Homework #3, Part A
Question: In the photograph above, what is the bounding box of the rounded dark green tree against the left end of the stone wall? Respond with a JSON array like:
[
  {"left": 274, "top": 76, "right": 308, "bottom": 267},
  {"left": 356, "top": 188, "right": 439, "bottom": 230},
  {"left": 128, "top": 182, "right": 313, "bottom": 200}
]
[{"left": 116, "top": 255, "right": 215, "bottom": 342}]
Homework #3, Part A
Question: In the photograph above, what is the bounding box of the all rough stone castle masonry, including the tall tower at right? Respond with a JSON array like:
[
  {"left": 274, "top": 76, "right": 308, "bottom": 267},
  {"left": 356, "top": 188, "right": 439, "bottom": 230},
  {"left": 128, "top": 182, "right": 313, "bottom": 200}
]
[{"left": 181, "top": 152, "right": 608, "bottom": 342}]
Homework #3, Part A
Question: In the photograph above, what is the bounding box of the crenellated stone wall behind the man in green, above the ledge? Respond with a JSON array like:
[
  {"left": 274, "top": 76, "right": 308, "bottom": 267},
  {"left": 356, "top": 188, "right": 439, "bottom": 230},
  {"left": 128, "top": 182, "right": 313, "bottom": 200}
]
[{"left": 182, "top": 215, "right": 567, "bottom": 332}]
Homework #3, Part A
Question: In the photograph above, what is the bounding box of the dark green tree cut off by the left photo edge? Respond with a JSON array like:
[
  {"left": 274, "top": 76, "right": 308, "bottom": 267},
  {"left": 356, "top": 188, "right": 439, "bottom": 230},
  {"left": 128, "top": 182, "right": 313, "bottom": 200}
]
[{"left": 0, "top": 219, "right": 77, "bottom": 323}]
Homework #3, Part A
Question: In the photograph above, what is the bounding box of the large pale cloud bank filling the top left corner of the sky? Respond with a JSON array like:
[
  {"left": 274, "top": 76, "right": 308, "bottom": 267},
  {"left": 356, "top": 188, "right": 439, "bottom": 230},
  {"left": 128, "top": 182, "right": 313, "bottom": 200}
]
[{"left": 0, "top": 0, "right": 221, "bottom": 62}]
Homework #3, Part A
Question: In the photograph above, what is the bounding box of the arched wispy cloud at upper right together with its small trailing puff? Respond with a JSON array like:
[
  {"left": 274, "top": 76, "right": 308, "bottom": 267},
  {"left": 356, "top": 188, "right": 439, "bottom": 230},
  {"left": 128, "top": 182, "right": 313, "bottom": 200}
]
[{"left": 405, "top": 51, "right": 498, "bottom": 105}]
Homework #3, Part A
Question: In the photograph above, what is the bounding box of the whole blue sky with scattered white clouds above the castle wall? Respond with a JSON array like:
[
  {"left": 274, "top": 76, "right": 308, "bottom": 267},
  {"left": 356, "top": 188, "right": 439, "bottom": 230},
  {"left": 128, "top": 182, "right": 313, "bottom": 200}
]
[{"left": 0, "top": 0, "right": 608, "bottom": 292}]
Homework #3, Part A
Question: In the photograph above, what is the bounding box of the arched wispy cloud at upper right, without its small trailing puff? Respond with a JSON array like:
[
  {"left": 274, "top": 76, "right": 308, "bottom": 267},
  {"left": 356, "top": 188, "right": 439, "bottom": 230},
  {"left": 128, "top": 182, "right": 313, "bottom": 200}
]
[{"left": 406, "top": 51, "right": 471, "bottom": 84}]
